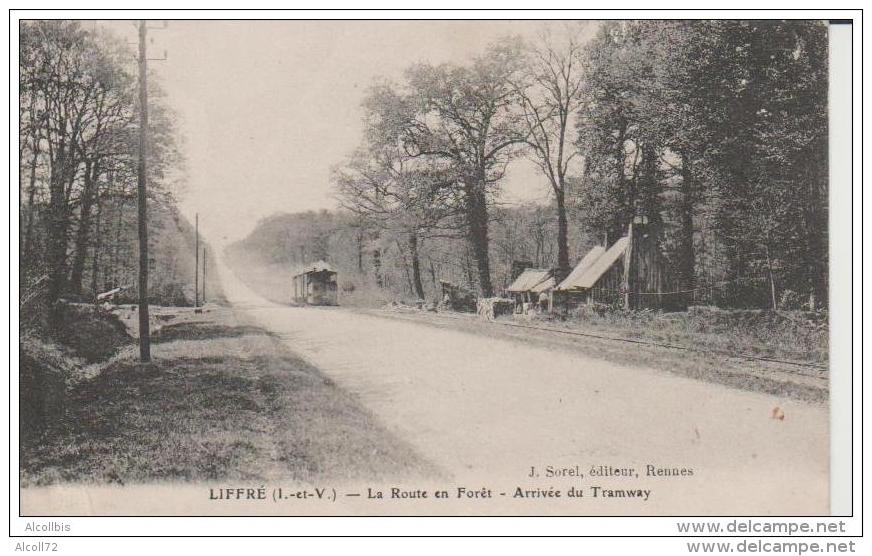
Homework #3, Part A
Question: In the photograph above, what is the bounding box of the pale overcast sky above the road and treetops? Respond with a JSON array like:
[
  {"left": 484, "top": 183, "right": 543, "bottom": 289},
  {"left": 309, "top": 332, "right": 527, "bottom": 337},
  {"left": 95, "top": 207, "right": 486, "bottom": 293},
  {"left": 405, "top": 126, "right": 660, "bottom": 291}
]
[{"left": 100, "top": 21, "right": 592, "bottom": 244}]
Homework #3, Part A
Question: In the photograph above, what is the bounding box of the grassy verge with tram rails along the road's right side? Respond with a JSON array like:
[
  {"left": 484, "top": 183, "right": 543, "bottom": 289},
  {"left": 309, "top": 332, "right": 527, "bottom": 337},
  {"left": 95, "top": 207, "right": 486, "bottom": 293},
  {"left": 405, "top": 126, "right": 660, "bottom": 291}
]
[{"left": 367, "top": 307, "right": 829, "bottom": 403}]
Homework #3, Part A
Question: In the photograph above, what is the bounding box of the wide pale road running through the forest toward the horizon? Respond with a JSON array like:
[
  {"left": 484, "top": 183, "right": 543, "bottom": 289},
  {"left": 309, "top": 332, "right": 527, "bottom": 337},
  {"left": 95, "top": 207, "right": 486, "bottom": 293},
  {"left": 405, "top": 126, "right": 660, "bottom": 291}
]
[{"left": 218, "top": 258, "right": 829, "bottom": 515}]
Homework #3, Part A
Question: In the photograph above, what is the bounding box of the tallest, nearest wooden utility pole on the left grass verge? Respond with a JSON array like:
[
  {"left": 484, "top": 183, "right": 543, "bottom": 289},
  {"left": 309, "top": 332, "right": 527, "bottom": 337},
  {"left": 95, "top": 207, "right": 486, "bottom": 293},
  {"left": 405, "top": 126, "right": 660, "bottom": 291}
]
[{"left": 136, "top": 20, "right": 151, "bottom": 363}]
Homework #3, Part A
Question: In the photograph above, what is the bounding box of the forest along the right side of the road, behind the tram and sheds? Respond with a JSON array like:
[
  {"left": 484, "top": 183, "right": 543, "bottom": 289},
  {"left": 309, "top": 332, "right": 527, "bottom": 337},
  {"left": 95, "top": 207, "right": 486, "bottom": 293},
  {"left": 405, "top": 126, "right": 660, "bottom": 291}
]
[{"left": 228, "top": 20, "right": 828, "bottom": 310}]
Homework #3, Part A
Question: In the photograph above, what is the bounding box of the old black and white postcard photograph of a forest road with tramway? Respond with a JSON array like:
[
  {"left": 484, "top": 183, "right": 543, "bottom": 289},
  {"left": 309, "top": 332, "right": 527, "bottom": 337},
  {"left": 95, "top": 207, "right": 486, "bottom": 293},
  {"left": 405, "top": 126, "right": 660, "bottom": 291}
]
[{"left": 10, "top": 12, "right": 859, "bottom": 534}]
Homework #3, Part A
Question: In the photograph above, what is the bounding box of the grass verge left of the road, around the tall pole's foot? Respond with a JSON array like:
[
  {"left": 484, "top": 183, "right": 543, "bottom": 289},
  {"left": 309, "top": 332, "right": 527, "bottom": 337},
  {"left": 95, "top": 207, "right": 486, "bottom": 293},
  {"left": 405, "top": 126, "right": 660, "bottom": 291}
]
[{"left": 21, "top": 308, "right": 436, "bottom": 486}]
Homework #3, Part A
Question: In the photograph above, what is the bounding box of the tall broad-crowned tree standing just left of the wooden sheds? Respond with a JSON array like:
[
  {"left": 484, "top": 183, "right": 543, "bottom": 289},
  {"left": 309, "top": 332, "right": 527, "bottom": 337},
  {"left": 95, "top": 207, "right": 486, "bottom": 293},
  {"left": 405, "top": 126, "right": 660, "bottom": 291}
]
[{"left": 371, "top": 40, "right": 526, "bottom": 297}]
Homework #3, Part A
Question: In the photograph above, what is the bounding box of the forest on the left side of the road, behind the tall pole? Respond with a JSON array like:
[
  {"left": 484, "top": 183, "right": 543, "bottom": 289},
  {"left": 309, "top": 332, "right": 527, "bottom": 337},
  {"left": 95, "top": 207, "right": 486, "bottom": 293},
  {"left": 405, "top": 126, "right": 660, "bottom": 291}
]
[{"left": 18, "top": 21, "right": 201, "bottom": 326}]
